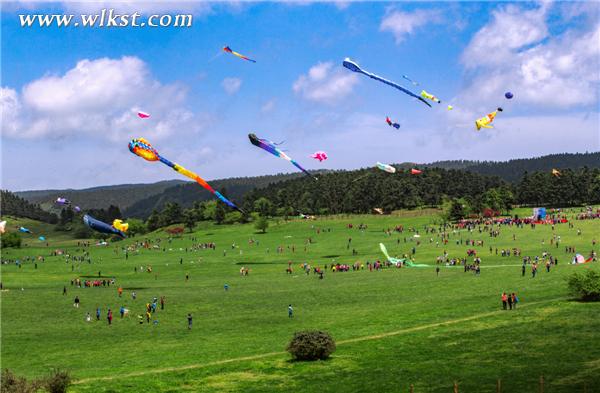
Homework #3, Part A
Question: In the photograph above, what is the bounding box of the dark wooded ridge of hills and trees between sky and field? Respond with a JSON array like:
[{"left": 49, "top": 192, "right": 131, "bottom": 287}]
[{"left": 13, "top": 152, "right": 600, "bottom": 225}]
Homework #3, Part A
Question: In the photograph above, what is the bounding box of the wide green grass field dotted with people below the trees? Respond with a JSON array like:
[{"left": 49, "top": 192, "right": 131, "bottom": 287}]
[{"left": 1, "top": 209, "right": 600, "bottom": 393}]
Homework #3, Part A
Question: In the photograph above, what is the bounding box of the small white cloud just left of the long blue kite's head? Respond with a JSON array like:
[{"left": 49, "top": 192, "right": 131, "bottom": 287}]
[{"left": 292, "top": 62, "right": 358, "bottom": 104}]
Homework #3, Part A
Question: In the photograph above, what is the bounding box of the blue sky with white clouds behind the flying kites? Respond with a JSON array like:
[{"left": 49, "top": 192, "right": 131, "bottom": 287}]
[{"left": 0, "top": 1, "right": 600, "bottom": 190}]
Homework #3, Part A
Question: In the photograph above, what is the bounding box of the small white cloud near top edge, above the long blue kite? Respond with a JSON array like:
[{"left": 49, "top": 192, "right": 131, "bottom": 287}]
[{"left": 379, "top": 10, "right": 441, "bottom": 44}]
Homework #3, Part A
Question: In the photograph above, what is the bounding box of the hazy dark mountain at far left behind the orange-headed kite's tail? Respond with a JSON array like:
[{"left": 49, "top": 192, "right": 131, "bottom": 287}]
[{"left": 15, "top": 180, "right": 186, "bottom": 210}]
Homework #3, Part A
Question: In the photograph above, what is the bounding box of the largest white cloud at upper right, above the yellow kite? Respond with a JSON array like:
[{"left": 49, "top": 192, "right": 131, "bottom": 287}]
[{"left": 456, "top": 4, "right": 600, "bottom": 109}]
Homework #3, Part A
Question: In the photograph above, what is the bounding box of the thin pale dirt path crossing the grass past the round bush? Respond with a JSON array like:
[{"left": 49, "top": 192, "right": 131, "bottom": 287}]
[{"left": 73, "top": 298, "right": 563, "bottom": 385}]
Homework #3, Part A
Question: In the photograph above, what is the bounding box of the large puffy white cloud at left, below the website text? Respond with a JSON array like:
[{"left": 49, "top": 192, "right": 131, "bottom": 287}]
[{"left": 1, "top": 57, "right": 200, "bottom": 141}]
